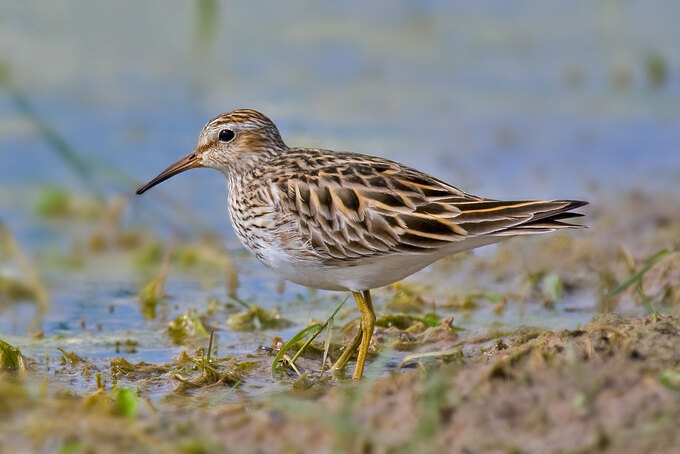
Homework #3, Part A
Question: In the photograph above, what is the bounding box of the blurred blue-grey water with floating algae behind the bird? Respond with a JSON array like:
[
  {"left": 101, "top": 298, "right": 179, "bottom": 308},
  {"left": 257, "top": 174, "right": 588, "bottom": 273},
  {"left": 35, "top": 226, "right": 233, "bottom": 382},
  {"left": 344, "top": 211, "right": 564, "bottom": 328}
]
[{"left": 0, "top": 0, "right": 680, "bottom": 392}]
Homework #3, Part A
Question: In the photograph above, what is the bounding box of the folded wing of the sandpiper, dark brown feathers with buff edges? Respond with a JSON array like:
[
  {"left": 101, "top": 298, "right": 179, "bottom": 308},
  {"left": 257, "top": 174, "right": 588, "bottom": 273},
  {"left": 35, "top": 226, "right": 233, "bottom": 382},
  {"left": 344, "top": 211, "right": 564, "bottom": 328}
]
[{"left": 266, "top": 149, "right": 580, "bottom": 261}]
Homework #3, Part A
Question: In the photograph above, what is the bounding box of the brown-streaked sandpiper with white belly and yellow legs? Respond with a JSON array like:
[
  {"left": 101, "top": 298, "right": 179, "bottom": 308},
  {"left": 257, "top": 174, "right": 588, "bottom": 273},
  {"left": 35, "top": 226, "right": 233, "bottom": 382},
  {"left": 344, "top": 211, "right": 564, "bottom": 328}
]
[{"left": 136, "top": 109, "right": 588, "bottom": 379}]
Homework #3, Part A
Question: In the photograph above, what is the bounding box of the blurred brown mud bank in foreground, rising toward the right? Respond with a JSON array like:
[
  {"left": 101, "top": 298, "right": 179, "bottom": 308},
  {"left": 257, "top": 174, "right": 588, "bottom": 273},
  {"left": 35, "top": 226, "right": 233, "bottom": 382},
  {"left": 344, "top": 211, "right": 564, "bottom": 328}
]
[{"left": 0, "top": 314, "right": 680, "bottom": 453}]
